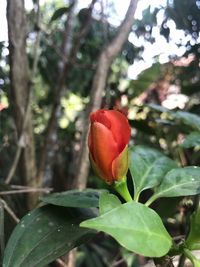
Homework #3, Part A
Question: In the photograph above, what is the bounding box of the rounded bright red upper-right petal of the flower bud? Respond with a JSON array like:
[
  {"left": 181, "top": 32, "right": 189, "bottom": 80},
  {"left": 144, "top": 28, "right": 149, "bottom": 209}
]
[{"left": 104, "top": 110, "right": 131, "bottom": 152}]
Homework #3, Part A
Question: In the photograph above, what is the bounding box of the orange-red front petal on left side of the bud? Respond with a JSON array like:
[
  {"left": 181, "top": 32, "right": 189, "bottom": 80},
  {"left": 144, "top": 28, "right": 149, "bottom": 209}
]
[{"left": 90, "top": 122, "right": 119, "bottom": 181}]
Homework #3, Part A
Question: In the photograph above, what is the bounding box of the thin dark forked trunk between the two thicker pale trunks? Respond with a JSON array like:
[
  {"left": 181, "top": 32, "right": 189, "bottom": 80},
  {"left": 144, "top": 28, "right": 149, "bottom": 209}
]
[{"left": 37, "top": 0, "right": 97, "bottom": 182}]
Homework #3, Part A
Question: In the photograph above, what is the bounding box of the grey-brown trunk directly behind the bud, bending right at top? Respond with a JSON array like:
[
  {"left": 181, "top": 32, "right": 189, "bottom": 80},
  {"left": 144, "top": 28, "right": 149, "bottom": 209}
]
[{"left": 74, "top": 0, "right": 138, "bottom": 189}]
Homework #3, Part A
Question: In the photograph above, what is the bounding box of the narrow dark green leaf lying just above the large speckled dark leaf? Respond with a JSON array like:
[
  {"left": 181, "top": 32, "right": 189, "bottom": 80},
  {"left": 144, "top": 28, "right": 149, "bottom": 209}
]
[{"left": 41, "top": 189, "right": 103, "bottom": 208}]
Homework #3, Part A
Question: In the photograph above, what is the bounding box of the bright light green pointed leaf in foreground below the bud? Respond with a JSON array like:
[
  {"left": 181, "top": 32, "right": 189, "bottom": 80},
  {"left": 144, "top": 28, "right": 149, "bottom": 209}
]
[{"left": 81, "top": 201, "right": 172, "bottom": 257}]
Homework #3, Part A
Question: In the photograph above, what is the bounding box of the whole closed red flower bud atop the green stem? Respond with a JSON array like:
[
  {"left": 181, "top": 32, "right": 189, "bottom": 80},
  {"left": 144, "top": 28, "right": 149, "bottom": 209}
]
[{"left": 88, "top": 109, "right": 131, "bottom": 184}]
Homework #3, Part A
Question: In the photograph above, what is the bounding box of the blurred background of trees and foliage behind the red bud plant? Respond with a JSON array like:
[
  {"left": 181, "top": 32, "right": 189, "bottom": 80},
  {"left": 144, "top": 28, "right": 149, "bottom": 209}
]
[{"left": 0, "top": 0, "right": 200, "bottom": 267}]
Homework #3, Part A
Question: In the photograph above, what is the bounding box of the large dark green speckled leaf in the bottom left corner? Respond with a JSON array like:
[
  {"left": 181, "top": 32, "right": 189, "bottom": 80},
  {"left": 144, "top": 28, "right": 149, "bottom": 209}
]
[{"left": 3, "top": 205, "right": 94, "bottom": 267}]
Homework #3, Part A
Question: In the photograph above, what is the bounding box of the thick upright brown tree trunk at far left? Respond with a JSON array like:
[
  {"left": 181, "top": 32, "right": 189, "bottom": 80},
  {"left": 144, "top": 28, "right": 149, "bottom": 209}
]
[{"left": 7, "top": 0, "right": 36, "bottom": 207}]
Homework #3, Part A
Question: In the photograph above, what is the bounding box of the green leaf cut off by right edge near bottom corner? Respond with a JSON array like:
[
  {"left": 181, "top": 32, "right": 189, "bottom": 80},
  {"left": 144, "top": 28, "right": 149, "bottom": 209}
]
[{"left": 185, "top": 209, "right": 200, "bottom": 250}]
